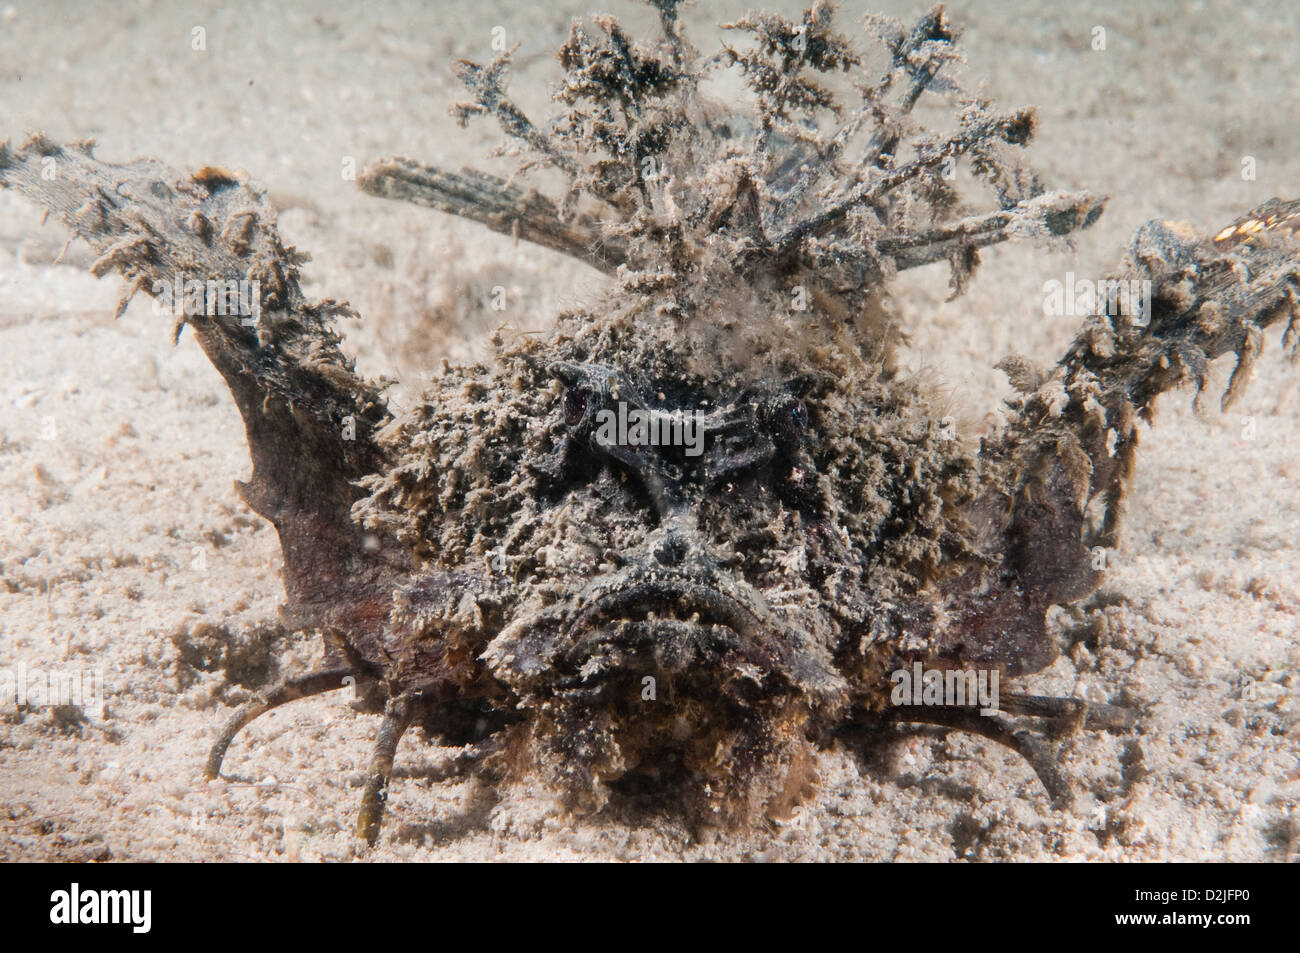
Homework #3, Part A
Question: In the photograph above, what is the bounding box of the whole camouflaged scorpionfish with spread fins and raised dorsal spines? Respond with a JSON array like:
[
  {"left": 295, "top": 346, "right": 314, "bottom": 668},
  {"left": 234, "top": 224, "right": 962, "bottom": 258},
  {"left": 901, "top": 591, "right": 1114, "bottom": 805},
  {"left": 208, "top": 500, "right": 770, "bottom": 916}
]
[{"left": 0, "top": 0, "right": 1300, "bottom": 840}]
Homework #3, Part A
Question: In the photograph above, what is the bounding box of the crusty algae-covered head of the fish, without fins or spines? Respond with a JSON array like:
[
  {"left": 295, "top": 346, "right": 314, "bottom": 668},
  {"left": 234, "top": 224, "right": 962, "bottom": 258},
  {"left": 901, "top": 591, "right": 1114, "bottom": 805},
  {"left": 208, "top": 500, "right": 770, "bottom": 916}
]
[{"left": 359, "top": 284, "right": 975, "bottom": 816}]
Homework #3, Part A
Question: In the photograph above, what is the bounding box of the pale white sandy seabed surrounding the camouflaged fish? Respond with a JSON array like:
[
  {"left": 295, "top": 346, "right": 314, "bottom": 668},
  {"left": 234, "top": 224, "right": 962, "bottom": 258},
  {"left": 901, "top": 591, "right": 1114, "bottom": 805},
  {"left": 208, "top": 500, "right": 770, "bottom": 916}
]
[{"left": 0, "top": 0, "right": 1300, "bottom": 861}]
